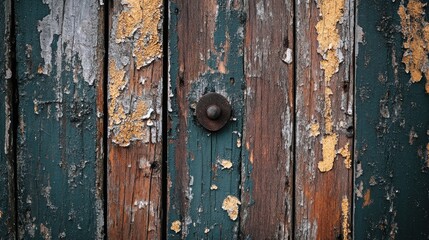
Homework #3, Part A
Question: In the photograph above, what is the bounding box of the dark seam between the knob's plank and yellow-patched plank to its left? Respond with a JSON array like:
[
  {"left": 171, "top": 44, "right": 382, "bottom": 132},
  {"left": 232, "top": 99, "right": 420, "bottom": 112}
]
[{"left": 161, "top": 0, "right": 169, "bottom": 239}]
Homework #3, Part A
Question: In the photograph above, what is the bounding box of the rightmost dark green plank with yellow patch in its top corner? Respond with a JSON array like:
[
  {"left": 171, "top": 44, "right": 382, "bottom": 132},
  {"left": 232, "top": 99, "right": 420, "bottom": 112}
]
[{"left": 354, "top": 0, "right": 429, "bottom": 239}]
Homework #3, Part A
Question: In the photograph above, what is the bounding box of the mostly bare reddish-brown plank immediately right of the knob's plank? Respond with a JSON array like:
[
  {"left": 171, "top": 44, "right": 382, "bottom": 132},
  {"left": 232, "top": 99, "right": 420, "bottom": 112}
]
[{"left": 241, "top": 0, "right": 295, "bottom": 239}]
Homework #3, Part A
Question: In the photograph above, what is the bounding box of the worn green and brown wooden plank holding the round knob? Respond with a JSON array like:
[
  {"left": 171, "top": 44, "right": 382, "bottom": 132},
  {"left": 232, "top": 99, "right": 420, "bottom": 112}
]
[{"left": 167, "top": 0, "right": 245, "bottom": 239}]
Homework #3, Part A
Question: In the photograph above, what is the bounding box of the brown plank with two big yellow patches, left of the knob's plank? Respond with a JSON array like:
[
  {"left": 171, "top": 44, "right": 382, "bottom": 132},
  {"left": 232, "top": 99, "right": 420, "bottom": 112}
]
[{"left": 107, "top": 0, "right": 163, "bottom": 239}]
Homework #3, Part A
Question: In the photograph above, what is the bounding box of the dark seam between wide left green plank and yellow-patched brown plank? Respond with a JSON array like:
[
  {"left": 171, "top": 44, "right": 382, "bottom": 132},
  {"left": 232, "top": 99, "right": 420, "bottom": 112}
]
[{"left": 103, "top": 0, "right": 110, "bottom": 239}]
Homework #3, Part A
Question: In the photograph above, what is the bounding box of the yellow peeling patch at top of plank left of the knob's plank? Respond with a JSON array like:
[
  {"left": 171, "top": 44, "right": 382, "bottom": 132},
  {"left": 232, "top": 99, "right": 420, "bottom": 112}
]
[{"left": 116, "top": 0, "right": 162, "bottom": 69}]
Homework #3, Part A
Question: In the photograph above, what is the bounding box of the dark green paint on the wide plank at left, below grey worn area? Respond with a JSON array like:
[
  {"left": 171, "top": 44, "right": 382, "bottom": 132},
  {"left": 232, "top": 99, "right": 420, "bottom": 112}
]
[{"left": 15, "top": 0, "right": 103, "bottom": 239}]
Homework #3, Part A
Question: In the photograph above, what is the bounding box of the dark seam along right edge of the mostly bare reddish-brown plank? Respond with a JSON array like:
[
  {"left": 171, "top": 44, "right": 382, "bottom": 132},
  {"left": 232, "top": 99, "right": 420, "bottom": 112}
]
[{"left": 289, "top": 1, "right": 298, "bottom": 239}]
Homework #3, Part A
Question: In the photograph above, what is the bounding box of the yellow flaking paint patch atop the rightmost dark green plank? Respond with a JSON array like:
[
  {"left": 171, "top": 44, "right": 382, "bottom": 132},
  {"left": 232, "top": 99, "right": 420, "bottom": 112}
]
[{"left": 398, "top": 0, "right": 429, "bottom": 93}]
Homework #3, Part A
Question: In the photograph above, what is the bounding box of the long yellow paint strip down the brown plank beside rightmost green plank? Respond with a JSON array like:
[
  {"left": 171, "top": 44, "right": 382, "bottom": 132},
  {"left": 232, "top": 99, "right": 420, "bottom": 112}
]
[{"left": 316, "top": 0, "right": 345, "bottom": 172}]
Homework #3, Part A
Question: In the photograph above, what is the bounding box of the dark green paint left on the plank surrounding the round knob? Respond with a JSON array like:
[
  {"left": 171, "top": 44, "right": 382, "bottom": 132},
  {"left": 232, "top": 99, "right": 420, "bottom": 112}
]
[{"left": 167, "top": 0, "right": 244, "bottom": 239}]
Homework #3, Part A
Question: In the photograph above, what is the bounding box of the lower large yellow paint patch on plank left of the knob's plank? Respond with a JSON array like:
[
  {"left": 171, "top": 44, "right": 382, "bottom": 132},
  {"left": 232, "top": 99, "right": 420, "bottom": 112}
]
[{"left": 108, "top": 61, "right": 153, "bottom": 147}]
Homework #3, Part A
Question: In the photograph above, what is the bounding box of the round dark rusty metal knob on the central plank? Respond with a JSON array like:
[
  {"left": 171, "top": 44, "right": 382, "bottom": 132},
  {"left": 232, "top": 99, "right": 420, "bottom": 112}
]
[{"left": 196, "top": 93, "right": 231, "bottom": 132}]
